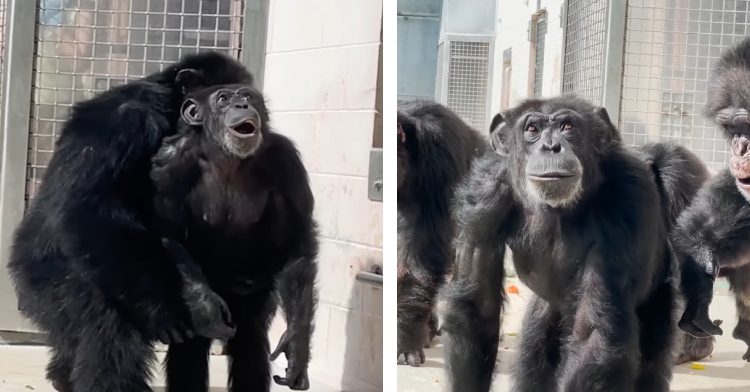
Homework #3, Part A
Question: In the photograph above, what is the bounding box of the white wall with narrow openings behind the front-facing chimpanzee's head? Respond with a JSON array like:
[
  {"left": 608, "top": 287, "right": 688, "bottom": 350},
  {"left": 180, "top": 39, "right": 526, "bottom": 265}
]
[{"left": 491, "top": 0, "right": 563, "bottom": 113}]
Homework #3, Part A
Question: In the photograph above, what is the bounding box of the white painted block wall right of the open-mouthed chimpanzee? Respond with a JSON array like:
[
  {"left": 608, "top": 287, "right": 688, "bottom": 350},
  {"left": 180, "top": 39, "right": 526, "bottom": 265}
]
[{"left": 264, "top": 0, "right": 388, "bottom": 392}]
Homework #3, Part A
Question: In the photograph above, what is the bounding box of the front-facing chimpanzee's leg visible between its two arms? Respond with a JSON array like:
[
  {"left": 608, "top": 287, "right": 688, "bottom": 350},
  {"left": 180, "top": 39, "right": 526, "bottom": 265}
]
[{"left": 513, "top": 296, "right": 562, "bottom": 392}]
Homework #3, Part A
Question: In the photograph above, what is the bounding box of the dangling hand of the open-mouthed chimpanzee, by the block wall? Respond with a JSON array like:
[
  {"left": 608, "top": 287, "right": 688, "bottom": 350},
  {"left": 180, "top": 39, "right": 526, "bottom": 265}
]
[{"left": 271, "top": 329, "right": 310, "bottom": 391}]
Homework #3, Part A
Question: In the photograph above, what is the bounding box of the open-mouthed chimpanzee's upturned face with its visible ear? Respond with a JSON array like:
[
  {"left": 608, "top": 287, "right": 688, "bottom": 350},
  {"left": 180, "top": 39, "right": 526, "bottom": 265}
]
[{"left": 182, "top": 85, "right": 267, "bottom": 159}]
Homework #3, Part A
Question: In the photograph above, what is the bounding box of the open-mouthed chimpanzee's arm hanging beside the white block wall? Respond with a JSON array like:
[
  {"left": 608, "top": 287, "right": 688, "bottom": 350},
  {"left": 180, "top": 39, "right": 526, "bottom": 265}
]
[{"left": 268, "top": 134, "right": 318, "bottom": 390}]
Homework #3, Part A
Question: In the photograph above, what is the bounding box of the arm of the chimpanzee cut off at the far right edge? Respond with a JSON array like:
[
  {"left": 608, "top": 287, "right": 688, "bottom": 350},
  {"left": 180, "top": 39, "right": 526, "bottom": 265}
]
[{"left": 672, "top": 169, "right": 750, "bottom": 337}]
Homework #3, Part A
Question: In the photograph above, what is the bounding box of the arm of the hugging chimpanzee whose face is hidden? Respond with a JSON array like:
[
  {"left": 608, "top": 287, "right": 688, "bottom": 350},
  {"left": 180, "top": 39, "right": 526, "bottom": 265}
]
[{"left": 56, "top": 83, "right": 229, "bottom": 340}]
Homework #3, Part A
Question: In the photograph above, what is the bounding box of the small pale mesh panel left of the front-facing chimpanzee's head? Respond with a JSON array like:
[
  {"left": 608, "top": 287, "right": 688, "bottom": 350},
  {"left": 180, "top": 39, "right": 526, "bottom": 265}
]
[{"left": 447, "top": 41, "right": 490, "bottom": 130}]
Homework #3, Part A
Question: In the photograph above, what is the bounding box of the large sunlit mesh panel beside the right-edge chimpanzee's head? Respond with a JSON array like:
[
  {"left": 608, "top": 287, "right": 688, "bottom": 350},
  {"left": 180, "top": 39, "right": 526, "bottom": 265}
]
[{"left": 620, "top": 0, "right": 750, "bottom": 169}]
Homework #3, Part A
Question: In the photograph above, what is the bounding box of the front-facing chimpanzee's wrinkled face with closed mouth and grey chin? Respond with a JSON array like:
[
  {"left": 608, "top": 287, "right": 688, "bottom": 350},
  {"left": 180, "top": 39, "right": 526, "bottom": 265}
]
[{"left": 515, "top": 109, "right": 586, "bottom": 208}]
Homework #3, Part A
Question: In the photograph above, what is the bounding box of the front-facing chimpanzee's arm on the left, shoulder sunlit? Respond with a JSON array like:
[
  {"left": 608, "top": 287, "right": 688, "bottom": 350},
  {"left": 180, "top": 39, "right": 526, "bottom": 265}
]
[{"left": 442, "top": 152, "right": 514, "bottom": 392}]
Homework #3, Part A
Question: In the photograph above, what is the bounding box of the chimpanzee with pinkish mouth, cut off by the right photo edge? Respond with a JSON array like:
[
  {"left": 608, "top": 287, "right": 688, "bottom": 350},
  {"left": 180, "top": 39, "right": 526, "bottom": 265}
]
[{"left": 674, "top": 38, "right": 750, "bottom": 362}]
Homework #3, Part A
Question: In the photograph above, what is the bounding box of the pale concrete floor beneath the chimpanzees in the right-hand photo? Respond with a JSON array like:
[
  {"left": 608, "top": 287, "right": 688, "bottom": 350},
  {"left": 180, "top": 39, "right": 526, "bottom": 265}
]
[{"left": 396, "top": 279, "right": 750, "bottom": 392}]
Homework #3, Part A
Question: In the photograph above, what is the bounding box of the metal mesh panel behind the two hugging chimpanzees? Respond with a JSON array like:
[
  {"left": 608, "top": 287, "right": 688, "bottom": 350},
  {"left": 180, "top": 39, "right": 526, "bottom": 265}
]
[{"left": 26, "top": 0, "right": 243, "bottom": 198}]
